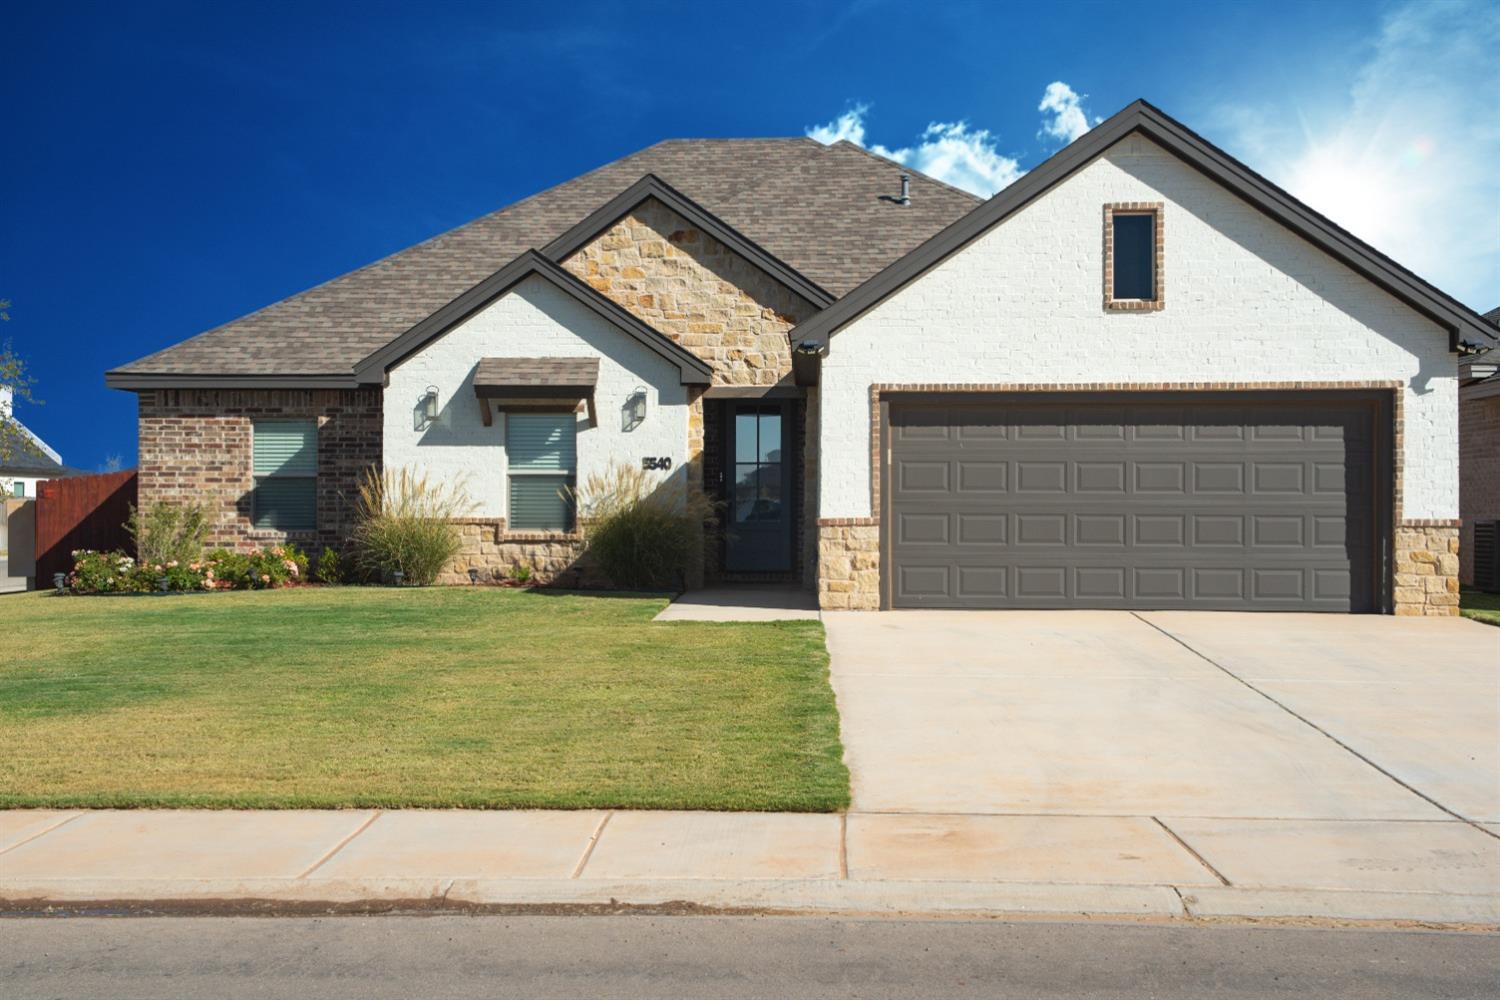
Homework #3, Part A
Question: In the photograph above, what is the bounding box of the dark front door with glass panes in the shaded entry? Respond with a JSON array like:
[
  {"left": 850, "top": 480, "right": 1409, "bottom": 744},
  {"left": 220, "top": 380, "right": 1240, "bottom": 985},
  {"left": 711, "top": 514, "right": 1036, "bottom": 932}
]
[{"left": 725, "top": 402, "right": 794, "bottom": 573}]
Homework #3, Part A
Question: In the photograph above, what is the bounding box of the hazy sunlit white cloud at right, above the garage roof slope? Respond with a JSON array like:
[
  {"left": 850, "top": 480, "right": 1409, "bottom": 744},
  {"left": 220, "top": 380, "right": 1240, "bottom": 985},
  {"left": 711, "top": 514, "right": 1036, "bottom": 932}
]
[{"left": 1220, "top": 1, "right": 1500, "bottom": 310}]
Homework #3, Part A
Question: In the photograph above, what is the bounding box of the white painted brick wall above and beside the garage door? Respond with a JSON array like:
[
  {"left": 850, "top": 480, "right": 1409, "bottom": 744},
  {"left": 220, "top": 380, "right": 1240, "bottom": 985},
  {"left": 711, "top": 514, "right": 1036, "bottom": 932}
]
[{"left": 819, "top": 136, "right": 1458, "bottom": 517}]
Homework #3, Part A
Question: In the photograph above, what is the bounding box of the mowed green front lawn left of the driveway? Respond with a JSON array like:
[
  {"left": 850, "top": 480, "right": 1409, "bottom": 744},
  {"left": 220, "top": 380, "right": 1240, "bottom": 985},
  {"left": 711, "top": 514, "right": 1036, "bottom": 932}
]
[{"left": 0, "top": 588, "right": 849, "bottom": 811}]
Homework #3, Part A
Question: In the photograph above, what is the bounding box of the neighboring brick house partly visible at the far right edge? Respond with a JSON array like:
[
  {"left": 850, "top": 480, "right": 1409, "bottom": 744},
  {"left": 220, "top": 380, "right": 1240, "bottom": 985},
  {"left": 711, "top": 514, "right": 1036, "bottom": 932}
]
[{"left": 1458, "top": 309, "right": 1500, "bottom": 583}]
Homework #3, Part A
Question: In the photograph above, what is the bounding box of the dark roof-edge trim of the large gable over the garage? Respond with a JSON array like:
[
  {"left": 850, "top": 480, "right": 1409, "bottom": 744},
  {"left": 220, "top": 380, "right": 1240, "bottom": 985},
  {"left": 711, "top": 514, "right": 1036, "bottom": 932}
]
[{"left": 792, "top": 100, "right": 1494, "bottom": 351}]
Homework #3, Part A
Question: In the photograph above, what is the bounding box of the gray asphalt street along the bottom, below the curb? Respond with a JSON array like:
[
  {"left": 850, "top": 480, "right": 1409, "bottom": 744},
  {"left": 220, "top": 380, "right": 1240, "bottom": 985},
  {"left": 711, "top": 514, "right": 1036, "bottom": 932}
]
[{"left": 0, "top": 915, "right": 1500, "bottom": 1000}]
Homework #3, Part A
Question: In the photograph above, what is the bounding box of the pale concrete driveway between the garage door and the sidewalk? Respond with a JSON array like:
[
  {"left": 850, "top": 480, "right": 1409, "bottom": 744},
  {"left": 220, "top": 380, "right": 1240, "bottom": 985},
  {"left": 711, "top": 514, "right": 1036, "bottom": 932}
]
[{"left": 825, "top": 612, "right": 1500, "bottom": 823}]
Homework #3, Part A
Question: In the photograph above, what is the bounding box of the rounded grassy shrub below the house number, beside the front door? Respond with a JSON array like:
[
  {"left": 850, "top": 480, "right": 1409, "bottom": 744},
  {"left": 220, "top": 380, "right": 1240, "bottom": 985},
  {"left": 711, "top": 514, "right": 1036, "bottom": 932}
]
[{"left": 573, "top": 465, "right": 714, "bottom": 591}]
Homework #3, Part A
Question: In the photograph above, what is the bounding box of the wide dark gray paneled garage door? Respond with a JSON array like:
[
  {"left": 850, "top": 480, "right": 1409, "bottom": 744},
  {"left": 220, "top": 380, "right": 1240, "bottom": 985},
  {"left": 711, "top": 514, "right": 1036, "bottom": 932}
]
[{"left": 884, "top": 394, "right": 1379, "bottom": 612}]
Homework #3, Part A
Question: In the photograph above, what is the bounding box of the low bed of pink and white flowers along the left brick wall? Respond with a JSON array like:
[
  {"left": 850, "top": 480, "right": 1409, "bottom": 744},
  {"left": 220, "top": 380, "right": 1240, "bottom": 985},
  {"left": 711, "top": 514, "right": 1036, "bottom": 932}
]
[{"left": 68, "top": 546, "right": 308, "bottom": 594}]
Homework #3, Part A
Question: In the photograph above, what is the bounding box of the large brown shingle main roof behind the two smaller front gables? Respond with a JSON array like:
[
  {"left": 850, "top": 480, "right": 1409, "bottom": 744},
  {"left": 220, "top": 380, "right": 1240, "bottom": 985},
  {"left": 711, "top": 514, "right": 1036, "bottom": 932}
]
[{"left": 117, "top": 138, "right": 980, "bottom": 375}]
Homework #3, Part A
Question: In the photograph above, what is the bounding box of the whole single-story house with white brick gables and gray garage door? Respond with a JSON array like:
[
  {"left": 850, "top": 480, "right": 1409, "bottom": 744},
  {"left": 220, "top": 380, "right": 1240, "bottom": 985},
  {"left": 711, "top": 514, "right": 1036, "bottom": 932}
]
[{"left": 108, "top": 102, "right": 1494, "bottom": 615}]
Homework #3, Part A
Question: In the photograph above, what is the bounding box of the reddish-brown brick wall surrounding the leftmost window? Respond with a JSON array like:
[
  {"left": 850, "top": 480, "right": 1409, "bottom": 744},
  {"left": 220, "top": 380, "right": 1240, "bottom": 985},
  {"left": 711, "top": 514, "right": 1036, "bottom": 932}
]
[{"left": 140, "top": 388, "right": 381, "bottom": 549}]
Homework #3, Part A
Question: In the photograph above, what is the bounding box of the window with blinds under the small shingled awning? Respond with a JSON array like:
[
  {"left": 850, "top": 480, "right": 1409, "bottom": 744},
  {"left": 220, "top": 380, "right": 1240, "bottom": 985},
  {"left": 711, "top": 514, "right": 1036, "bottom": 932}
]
[{"left": 506, "top": 412, "right": 578, "bottom": 531}]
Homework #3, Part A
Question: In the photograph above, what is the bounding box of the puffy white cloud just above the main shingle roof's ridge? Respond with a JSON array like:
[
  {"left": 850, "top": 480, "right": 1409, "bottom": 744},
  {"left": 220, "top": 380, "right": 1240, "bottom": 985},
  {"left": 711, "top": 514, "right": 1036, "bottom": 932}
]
[{"left": 807, "top": 103, "right": 1026, "bottom": 198}]
